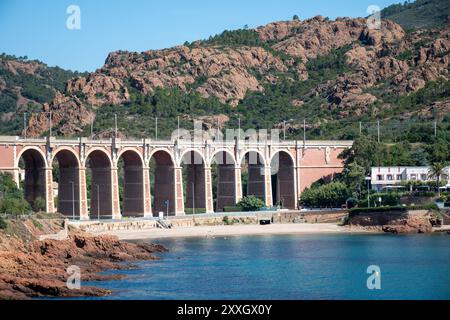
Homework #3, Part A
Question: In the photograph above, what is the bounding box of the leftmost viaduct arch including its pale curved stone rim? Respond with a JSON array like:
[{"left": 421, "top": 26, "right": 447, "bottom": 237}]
[{"left": 16, "top": 147, "right": 48, "bottom": 209}]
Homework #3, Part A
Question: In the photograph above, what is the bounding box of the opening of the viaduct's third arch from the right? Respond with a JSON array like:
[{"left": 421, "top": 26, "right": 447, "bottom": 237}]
[{"left": 211, "top": 151, "right": 236, "bottom": 212}]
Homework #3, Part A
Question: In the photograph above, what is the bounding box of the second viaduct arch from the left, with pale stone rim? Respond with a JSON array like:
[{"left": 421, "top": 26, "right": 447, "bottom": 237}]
[{"left": 51, "top": 148, "right": 80, "bottom": 218}]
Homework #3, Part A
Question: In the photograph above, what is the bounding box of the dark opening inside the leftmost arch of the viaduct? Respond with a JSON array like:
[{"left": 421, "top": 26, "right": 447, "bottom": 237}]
[{"left": 19, "top": 149, "right": 47, "bottom": 211}]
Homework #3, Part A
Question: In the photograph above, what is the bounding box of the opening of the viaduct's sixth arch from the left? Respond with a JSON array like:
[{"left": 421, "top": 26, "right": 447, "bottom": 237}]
[{"left": 181, "top": 151, "right": 206, "bottom": 214}]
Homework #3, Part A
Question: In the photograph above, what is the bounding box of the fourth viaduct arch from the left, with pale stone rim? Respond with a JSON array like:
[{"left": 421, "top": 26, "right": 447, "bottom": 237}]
[{"left": 116, "top": 148, "right": 145, "bottom": 217}]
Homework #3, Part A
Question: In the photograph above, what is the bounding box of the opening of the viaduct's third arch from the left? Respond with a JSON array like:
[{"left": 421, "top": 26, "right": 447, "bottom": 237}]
[{"left": 86, "top": 150, "right": 112, "bottom": 219}]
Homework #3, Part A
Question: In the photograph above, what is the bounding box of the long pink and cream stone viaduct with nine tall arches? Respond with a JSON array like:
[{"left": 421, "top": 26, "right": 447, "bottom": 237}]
[{"left": 0, "top": 136, "right": 352, "bottom": 220}]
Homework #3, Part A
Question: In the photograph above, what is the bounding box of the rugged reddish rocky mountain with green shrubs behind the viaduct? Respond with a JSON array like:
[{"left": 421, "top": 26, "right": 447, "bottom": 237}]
[{"left": 0, "top": 0, "right": 450, "bottom": 141}]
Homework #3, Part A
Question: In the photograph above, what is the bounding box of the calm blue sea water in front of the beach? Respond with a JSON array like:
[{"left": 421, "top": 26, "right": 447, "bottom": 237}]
[{"left": 78, "top": 234, "right": 450, "bottom": 300}]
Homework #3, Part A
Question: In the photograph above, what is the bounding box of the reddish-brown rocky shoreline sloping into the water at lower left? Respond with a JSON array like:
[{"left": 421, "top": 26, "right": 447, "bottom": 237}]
[{"left": 0, "top": 219, "right": 167, "bottom": 299}]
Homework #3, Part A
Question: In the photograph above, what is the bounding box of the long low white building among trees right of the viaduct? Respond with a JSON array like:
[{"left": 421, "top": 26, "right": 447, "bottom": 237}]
[{"left": 371, "top": 167, "right": 450, "bottom": 191}]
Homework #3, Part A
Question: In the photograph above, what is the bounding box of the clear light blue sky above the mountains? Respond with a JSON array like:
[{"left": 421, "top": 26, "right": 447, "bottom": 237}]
[{"left": 0, "top": 0, "right": 399, "bottom": 71}]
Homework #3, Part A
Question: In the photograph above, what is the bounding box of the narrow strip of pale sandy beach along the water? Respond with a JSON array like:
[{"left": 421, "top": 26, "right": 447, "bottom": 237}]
[{"left": 91, "top": 223, "right": 370, "bottom": 240}]
